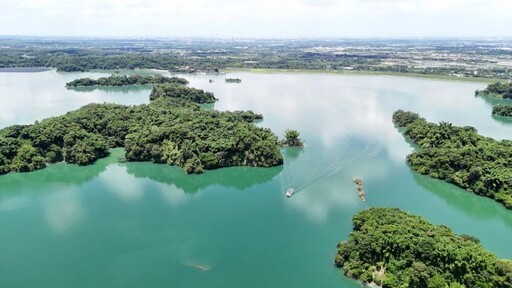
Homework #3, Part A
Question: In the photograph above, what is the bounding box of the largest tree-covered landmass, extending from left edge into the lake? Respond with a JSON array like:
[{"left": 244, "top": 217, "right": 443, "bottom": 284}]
[{"left": 0, "top": 84, "right": 283, "bottom": 174}]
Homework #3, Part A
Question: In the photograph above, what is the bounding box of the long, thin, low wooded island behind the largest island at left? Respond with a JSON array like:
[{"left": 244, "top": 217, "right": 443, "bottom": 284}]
[{"left": 66, "top": 75, "right": 188, "bottom": 88}]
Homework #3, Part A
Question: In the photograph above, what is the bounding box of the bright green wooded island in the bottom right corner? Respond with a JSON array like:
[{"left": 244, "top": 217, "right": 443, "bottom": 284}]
[{"left": 334, "top": 208, "right": 512, "bottom": 288}]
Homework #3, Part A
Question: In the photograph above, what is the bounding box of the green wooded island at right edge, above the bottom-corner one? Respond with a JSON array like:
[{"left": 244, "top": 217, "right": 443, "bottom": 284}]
[{"left": 393, "top": 110, "right": 512, "bottom": 209}]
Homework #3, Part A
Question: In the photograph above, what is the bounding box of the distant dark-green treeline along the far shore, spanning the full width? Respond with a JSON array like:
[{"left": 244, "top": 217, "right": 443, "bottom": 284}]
[{"left": 0, "top": 47, "right": 512, "bottom": 79}]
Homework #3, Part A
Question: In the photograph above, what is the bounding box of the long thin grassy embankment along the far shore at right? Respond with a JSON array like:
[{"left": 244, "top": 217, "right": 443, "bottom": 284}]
[{"left": 219, "top": 68, "right": 507, "bottom": 83}]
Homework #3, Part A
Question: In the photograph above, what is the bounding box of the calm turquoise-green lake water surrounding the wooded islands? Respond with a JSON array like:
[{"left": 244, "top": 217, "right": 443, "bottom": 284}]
[{"left": 0, "top": 71, "right": 512, "bottom": 287}]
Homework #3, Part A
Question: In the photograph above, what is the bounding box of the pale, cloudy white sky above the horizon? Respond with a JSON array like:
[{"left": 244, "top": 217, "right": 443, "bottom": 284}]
[{"left": 0, "top": 0, "right": 512, "bottom": 38}]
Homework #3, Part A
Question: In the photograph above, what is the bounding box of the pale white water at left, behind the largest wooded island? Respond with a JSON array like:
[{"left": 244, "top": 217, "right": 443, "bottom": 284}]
[{"left": 0, "top": 70, "right": 150, "bottom": 127}]
